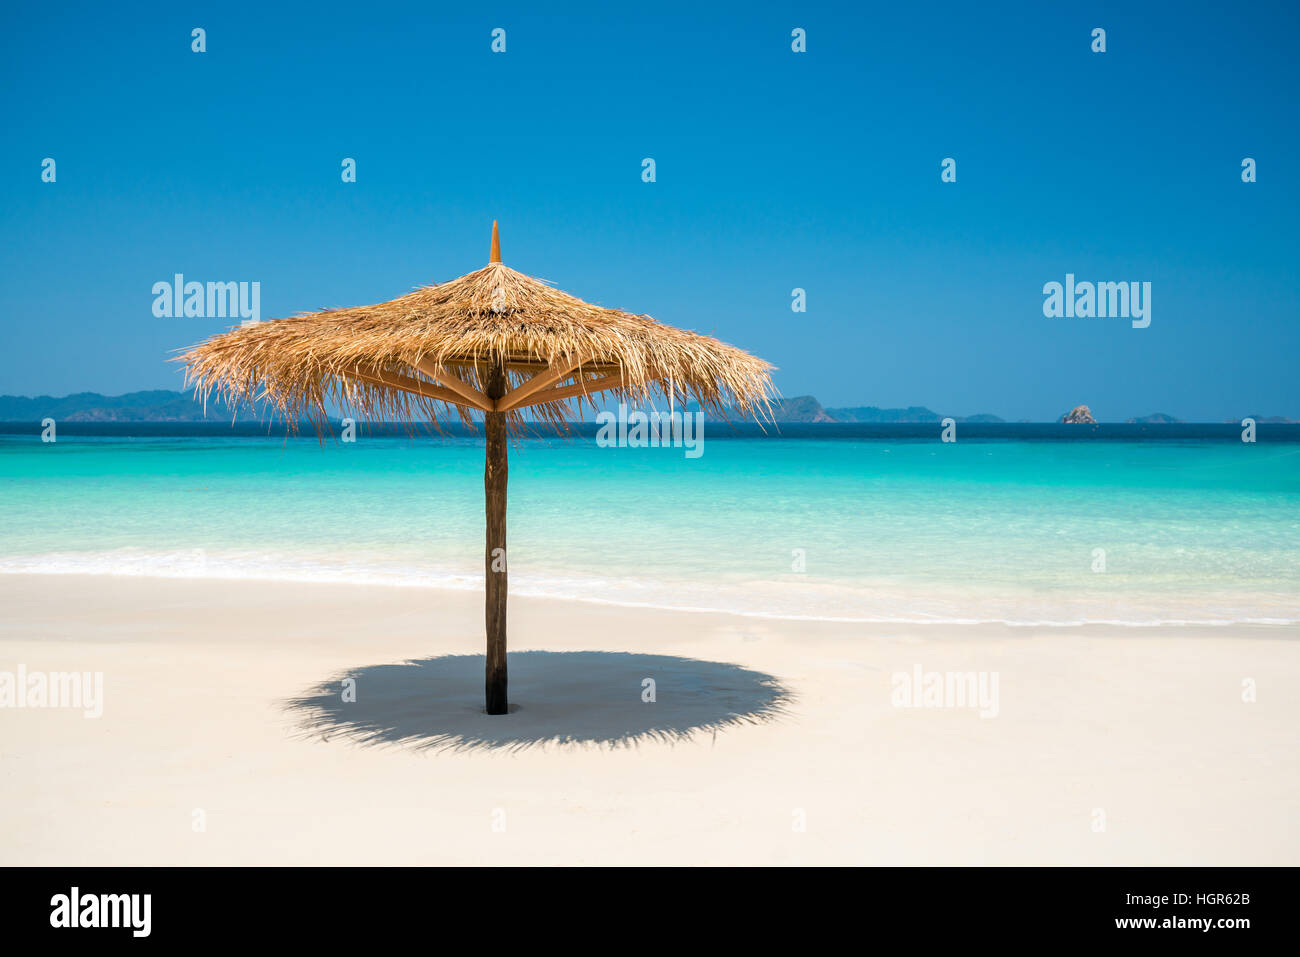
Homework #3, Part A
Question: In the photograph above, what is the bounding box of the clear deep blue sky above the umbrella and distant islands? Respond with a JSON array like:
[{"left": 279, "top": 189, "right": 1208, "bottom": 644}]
[{"left": 0, "top": 3, "right": 1300, "bottom": 421}]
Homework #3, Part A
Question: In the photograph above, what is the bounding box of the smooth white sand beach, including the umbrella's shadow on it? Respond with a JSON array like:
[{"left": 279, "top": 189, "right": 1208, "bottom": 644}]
[{"left": 0, "top": 575, "right": 1300, "bottom": 865}]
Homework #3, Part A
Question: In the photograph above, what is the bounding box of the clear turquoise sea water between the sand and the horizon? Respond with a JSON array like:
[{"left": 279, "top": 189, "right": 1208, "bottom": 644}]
[{"left": 0, "top": 424, "right": 1300, "bottom": 625}]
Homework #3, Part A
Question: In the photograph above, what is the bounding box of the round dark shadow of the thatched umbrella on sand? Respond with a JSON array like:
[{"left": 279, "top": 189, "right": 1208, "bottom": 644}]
[{"left": 286, "top": 651, "right": 793, "bottom": 752}]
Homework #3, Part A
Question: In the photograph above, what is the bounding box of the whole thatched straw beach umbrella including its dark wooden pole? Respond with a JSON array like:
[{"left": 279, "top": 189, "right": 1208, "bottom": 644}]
[{"left": 179, "top": 221, "right": 776, "bottom": 714}]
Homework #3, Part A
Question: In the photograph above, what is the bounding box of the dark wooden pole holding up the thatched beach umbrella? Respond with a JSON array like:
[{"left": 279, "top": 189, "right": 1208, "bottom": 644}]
[{"left": 484, "top": 363, "right": 510, "bottom": 714}]
